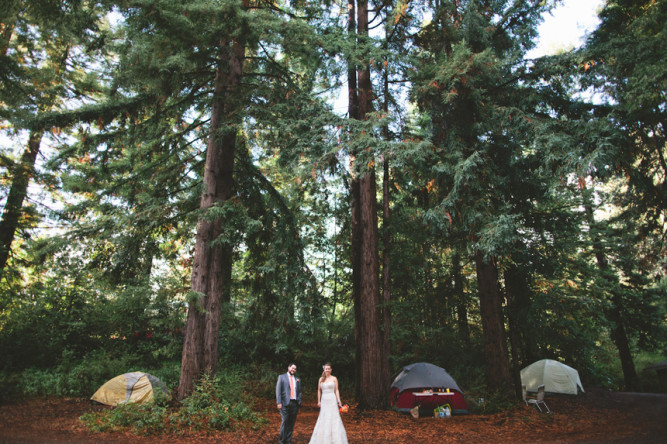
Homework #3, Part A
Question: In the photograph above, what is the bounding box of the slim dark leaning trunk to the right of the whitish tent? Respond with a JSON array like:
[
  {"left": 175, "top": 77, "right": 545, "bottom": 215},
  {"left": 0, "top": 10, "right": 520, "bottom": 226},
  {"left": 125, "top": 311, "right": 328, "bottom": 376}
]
[{"left": 582, "top": 186, "right": 639, "bottom": 390}]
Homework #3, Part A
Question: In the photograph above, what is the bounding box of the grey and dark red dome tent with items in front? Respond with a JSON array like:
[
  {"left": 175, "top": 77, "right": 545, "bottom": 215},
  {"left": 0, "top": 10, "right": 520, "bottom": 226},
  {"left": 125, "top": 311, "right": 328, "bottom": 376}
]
[{"left": 389, "top": 362, "right": 468, "bottom": 414}]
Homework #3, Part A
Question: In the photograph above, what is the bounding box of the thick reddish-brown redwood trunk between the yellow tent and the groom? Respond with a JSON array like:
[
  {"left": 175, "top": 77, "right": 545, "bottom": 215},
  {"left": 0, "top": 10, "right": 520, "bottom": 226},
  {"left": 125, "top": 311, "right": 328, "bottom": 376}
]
[{"left": 178, "top": 36, "right": 245, "bottom": 400}]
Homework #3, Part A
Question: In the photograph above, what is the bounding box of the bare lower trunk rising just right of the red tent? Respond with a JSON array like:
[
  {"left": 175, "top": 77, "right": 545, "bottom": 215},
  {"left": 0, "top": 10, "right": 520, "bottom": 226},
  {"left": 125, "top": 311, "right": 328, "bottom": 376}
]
[{"left": 475, "top": 250, "right": 512, "bottom": 393}]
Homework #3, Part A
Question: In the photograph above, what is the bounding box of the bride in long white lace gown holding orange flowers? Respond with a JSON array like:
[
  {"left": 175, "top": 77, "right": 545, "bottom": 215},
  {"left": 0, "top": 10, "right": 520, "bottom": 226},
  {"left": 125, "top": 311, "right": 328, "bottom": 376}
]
[{"left": 310, "top": 363, "right": 347, "bottom": 444}]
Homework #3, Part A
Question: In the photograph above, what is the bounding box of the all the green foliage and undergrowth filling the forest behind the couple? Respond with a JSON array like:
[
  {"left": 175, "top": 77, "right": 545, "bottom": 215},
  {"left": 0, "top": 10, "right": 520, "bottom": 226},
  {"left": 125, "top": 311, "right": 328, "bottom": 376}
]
[{"left": 0, "top": 0, "right": 667, "bottom": 408}]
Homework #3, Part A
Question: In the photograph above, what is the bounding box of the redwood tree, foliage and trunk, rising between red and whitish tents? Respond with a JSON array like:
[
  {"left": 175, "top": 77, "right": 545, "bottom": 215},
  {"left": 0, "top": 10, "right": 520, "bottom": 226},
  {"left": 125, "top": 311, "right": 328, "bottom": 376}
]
[{"left": 412, "top": 0, "right": 553, "bottom": 394}]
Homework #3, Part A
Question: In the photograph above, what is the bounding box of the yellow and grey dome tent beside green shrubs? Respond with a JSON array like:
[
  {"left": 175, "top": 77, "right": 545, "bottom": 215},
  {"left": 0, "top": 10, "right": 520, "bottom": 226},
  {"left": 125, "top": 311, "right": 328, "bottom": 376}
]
[{"left": 90, "top": 372, "right": 170, "bottom": 406}]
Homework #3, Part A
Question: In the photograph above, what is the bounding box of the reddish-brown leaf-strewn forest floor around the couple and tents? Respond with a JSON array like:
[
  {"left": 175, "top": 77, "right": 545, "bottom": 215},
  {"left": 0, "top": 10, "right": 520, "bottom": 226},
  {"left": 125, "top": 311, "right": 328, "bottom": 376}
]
[{"left": 0, "top": 390, "right": 667, "bottom": 444}]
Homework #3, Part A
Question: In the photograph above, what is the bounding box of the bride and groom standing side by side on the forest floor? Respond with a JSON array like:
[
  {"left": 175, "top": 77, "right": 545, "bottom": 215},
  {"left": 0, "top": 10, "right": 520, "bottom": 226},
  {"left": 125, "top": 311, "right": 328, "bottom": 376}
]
[{"left": 276, "top": 363, "right": 347, "bottom": 444}]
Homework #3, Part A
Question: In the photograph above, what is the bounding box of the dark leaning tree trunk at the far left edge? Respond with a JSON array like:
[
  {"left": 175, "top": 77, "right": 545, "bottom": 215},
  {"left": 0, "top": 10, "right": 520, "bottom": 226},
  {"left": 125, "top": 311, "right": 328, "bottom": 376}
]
[{"left": 0, "top": 131, "right": 43, "bottom": 273}]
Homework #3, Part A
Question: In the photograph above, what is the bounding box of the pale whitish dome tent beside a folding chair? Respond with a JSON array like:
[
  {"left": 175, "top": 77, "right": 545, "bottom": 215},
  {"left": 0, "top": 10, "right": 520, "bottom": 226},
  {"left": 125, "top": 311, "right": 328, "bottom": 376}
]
[{"left": 521, "top": 359, "right": 584, "bottom": 395}]
